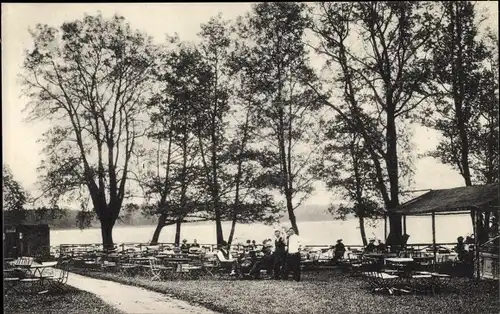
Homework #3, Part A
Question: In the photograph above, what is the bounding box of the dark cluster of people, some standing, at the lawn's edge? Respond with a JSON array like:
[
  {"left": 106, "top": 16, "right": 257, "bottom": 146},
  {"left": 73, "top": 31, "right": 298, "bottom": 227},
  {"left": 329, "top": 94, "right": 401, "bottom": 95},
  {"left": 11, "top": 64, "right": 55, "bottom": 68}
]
[{"left": 217, "top": 228, "right": 302, "bottom": 281}]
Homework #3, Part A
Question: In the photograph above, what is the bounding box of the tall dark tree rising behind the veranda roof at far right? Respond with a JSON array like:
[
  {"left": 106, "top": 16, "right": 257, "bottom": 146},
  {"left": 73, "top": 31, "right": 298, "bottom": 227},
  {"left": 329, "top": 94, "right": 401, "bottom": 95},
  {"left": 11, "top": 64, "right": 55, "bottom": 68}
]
[{"left": 424, "top": 1, "right": 492, "bottom": 186}]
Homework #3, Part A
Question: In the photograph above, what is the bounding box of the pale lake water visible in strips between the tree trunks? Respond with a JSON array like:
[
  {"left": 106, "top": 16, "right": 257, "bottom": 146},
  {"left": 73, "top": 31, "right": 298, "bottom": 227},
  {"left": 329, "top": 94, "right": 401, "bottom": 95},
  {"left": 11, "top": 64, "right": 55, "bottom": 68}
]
[{"left": 50, "top": 215, "right": 472, "bottom": 246}]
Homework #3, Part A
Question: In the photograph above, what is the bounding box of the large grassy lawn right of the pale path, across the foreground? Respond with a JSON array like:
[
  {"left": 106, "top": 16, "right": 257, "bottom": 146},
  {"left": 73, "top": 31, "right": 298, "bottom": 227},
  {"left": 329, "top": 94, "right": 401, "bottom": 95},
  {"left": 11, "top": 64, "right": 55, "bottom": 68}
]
[{"left": 70, "top": 271, "right": 500, "bottom": 314}]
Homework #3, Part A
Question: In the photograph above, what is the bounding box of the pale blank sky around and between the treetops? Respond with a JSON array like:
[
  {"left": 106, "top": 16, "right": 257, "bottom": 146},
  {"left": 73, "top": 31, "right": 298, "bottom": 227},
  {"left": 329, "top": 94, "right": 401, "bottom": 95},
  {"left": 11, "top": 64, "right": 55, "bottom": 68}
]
[{"left": 1, "top": 1, "right": 498, "bottom": 209}]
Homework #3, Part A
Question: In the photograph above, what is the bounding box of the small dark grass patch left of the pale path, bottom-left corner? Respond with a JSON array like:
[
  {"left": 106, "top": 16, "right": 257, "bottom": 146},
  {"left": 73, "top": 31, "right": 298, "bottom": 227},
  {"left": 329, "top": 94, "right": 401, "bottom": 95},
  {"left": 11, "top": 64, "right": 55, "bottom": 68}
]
[{"left": 4, "top": 287, "right": 123, "bottom": 314}]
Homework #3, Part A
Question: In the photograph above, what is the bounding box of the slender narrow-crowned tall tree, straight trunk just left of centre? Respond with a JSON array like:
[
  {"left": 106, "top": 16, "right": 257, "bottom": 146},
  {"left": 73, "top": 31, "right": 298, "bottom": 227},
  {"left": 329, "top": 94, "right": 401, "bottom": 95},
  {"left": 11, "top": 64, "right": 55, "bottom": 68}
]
[{"left": 194, "top": 15, "right": 235, "bottom": 244}]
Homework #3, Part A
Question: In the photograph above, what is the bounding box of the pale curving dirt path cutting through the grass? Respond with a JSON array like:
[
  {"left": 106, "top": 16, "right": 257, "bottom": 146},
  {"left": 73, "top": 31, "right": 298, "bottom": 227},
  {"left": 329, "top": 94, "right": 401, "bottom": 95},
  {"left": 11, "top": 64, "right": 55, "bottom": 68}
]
[{"left": 68, "top": 273, "right": 216, "bottom": 314}]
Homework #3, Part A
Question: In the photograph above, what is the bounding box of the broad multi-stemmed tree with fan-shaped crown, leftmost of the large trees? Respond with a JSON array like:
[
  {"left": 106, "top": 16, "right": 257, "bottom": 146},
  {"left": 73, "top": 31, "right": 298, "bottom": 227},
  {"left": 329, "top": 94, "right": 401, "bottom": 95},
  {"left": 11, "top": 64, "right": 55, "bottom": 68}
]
[{"left": 22, "top": 14, "right": 156, "bottom": 249}]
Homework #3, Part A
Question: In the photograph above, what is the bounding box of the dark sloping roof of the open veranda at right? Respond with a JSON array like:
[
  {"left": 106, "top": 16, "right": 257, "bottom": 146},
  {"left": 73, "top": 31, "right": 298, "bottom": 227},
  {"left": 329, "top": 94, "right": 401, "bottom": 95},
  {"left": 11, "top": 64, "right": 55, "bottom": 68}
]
[{"left": 389, "top": 183, "right": 499, "bottom": 215}]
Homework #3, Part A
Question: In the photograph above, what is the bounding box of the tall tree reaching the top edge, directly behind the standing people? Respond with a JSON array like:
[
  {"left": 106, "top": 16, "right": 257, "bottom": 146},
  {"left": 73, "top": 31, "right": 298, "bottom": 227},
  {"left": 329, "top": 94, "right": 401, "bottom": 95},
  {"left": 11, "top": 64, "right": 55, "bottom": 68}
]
[{"left": 241, "top": 3, "right": 319, "bottom": 233}]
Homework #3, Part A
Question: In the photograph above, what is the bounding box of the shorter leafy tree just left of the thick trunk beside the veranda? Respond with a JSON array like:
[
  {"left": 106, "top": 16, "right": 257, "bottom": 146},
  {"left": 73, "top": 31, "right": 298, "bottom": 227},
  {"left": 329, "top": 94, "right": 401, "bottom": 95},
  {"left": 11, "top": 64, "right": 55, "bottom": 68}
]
[{"left": 316, "top": 117, "right": 380, "bottom": 246}]
